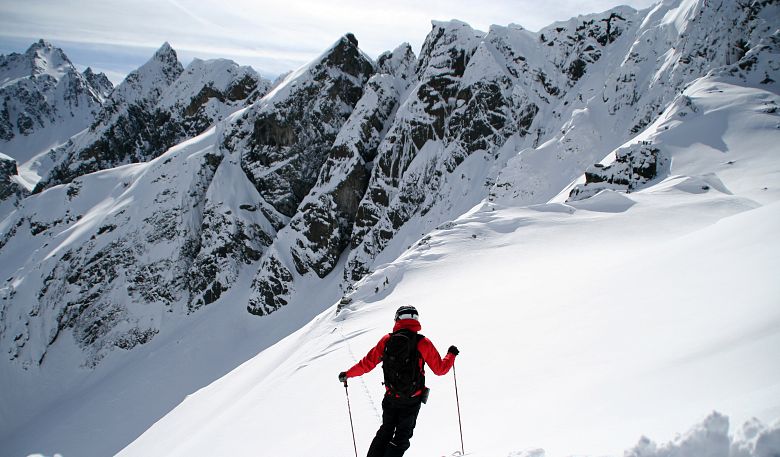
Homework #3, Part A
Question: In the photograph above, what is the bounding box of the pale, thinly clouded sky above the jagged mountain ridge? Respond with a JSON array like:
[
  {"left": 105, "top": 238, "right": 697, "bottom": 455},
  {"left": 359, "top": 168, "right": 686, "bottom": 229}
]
[{"left": 0, "top": 0, "right": 658, "bottom": 84}]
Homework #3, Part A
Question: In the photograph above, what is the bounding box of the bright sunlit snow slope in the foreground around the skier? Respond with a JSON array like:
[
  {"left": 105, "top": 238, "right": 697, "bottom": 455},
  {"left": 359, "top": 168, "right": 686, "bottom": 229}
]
[{"left": 120, "top": 80, "right": 780, "bottom": 457}]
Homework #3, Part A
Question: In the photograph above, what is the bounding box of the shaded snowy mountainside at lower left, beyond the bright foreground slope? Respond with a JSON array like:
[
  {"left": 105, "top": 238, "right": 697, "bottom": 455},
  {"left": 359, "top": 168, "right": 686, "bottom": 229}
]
[{"left": 0, "top": 119, "right": 338, "bottom": 456}]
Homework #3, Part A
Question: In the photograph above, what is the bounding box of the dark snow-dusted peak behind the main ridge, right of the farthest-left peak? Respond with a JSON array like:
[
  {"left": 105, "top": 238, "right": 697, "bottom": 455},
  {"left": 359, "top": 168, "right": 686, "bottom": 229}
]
[{"left": 34, "top": 43, "right": 270, "bottom": 192}]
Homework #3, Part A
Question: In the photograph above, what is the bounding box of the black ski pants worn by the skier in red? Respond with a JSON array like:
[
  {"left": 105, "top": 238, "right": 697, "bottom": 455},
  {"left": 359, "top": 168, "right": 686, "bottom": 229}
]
[{"left": 366, "top": 395, "right": 422, "bottom": 457}]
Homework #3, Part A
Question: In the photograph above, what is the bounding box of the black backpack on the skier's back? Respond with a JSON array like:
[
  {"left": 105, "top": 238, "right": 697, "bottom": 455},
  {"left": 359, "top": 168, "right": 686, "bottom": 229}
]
[{"left": 382, "top": 329, "right": 425, "bottom": 398}]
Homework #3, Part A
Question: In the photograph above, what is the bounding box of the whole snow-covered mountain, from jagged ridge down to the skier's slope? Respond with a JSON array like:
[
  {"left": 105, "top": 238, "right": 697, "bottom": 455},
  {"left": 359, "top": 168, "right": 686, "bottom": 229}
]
[{"left": 0, "top": 0, "right": 780, "bottom": 456}]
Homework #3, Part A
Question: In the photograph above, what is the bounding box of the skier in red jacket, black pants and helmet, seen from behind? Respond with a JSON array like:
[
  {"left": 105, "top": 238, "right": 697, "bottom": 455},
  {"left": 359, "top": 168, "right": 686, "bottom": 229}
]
[{"left": 339, "top": 306, "right": 459, "bottom": 457}]
